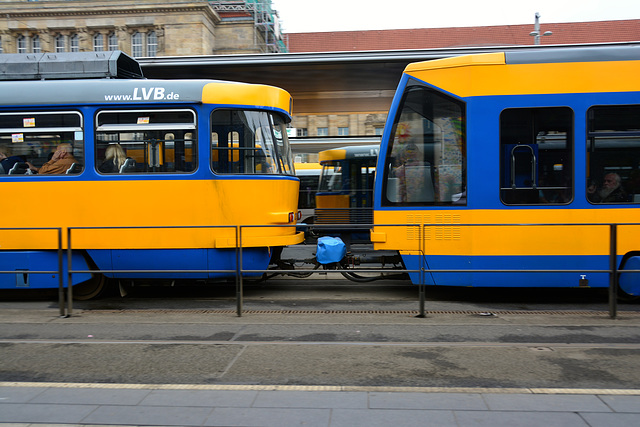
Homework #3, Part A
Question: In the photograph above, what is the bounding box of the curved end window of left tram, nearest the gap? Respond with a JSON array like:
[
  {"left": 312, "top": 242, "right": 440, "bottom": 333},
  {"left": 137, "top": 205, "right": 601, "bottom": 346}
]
[{"left": 211, "top": 109, "right": 294, "bottom": 175}]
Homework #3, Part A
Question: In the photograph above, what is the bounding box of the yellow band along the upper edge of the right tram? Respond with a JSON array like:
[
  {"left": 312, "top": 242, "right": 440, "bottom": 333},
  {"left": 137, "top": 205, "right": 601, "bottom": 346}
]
[{"left": 405, "top": 54, "right": 640, "bottom": 97}]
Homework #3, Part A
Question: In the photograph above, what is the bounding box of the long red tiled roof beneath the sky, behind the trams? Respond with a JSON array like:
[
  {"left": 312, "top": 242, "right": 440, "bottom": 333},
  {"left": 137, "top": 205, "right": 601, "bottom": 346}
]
[{"left": 285, "top": 19, "right": 640, "bottom": 53}]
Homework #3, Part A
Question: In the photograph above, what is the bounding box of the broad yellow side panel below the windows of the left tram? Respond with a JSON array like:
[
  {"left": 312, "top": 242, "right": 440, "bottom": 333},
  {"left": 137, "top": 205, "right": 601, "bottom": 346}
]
[{"left": 0, "top": 177, "right": 301, "bottom": 250}]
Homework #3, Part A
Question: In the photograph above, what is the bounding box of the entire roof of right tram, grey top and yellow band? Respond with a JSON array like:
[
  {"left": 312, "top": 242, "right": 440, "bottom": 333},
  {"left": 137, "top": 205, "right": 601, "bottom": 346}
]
[{"left": 404, "top": 43, "right": 640, "bottom": 97}]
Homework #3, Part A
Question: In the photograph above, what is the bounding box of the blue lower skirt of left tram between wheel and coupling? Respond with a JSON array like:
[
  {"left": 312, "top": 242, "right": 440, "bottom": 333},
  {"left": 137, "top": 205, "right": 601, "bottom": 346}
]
[{"left": 88, "top": 248, "right": 271, "bottom": 279}]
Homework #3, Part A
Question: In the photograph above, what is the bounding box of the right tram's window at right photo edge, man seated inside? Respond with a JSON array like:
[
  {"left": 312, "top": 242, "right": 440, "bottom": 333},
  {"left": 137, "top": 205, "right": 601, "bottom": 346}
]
[{"left": 586, "top": 105, "right": 640, "bottom": 203}]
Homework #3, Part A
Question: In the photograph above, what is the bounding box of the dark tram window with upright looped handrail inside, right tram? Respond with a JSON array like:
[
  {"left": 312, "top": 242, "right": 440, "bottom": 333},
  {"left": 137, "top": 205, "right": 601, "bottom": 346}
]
[{"left": 500, "top": 107, "right": 574, "bottom": 205}]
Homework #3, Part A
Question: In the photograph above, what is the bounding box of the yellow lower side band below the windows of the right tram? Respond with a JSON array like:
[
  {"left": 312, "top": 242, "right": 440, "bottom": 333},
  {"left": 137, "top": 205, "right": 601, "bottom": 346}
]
[{"left": 372, "top": 209, "right": 640, "bottom": 256}]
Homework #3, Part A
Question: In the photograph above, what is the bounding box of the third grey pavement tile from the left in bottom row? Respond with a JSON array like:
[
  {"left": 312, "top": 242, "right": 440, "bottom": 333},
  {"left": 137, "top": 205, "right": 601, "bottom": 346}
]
[{"left": 203, "top": 408, "right": 331, "bottom": 427}]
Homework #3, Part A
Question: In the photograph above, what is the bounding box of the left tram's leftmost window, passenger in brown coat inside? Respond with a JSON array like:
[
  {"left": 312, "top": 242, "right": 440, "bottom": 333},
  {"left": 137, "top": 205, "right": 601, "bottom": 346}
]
[{"left": 0, "top": 111, "right": 84, "bottom": 175}]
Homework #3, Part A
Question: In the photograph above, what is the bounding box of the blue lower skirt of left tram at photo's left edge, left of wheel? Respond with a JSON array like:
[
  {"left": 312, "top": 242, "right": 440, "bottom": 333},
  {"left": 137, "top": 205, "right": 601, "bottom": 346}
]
[{"left": 0, "top": 251, "right": 91, "bottom": 289}]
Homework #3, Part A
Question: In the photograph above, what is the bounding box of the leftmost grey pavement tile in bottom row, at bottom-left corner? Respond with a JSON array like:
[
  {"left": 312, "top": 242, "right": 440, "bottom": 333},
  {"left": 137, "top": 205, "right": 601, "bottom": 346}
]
[{"left": 0, "top": 403, "right": 97, "bottom": 424}]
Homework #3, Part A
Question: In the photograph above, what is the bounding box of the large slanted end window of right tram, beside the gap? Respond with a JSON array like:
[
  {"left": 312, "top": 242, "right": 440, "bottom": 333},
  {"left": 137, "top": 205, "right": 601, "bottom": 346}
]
[{"left": 381, "top": 82, "right": 466, "bottom": 206}]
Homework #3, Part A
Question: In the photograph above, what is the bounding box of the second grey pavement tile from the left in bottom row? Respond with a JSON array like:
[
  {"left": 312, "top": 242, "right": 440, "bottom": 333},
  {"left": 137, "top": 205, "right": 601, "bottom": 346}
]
[{"left": 82, "top": 405, "right": 211, "bottom": 426}]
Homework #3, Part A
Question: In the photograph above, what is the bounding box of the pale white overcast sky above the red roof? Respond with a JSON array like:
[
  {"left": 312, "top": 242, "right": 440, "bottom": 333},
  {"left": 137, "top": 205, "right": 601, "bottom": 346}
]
[{"left": 272, "top": 0, "right": 640, "bottom": 33}]
